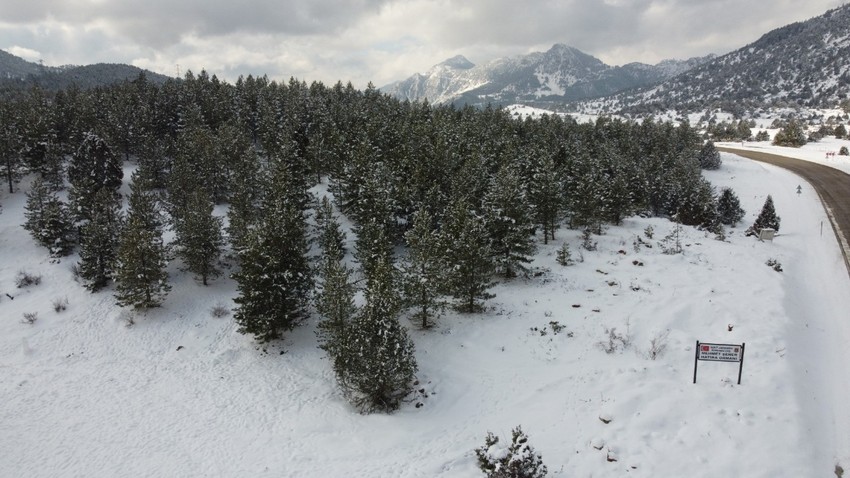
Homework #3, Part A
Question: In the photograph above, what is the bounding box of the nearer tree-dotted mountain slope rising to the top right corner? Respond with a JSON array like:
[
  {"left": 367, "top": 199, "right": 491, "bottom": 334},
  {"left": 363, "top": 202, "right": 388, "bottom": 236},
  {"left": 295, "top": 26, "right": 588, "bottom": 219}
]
[{"left": 595, "top": 5, "right": 850, "bottom": 112}]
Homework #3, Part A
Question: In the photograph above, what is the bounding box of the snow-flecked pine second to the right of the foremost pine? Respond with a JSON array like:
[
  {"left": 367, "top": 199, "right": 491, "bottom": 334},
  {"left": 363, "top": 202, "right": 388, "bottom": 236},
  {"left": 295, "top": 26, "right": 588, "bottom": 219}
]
[{"left": 440, "top": 198, "right": 495, "bottom": 312}]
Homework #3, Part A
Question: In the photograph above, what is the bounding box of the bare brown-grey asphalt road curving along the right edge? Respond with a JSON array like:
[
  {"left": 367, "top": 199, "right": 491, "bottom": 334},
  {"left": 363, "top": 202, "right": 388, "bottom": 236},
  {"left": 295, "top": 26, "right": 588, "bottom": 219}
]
[{"left": 717, "top": 146, "right": 850, "bottom": 273}]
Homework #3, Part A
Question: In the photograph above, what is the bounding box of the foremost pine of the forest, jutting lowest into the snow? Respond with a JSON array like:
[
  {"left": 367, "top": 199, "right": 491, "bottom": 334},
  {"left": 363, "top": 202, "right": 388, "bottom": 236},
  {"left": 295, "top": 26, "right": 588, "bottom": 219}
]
[{"left": 334, "top": 252, "right": 417, "bottom": 413}]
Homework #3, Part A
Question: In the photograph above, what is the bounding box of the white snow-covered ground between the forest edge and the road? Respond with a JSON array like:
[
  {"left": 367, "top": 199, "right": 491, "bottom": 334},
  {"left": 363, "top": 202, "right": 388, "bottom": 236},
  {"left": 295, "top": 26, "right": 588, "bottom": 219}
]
[{"left": 0, "top": 154, "right": 850, "bottom": 477}]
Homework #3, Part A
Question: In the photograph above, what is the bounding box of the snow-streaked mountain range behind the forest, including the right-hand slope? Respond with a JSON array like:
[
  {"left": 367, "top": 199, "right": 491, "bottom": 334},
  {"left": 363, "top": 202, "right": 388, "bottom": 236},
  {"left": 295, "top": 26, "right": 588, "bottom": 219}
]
[{"left": 381, "top": 5, "right": 850, "bottom": 112}]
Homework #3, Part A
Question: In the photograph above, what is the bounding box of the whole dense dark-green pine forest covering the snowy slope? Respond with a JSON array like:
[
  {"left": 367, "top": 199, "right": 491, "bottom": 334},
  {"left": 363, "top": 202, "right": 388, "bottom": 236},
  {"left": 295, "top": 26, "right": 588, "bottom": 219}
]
[{"left": 0, "top": 72, "right": 723, "bottom": 411}]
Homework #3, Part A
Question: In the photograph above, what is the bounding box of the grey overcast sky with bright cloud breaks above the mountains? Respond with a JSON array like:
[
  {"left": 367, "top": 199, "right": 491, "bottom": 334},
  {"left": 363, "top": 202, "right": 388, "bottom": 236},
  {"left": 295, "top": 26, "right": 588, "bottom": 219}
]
[{"left": 0, "top": 0, "right": 846, "bottom": 88}]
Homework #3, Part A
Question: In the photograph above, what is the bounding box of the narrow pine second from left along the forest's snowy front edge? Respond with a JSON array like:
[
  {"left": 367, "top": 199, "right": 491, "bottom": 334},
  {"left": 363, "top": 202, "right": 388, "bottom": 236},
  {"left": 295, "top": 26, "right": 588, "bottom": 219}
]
[{"left": 80, "top": 189, "right": 124, "bottom": 292}]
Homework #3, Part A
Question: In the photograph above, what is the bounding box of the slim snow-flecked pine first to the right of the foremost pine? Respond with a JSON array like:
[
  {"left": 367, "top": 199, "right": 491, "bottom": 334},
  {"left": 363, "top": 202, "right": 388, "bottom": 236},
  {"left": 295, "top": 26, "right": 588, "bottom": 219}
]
[{"left": 402, "top": 208, "right": 446, "bottom": 328}]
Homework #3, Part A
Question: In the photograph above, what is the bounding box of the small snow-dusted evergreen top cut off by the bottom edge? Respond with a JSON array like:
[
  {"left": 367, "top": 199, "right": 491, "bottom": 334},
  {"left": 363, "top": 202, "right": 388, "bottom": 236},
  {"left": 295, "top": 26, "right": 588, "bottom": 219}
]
[{"left": 475, "top": 426, "right": 549, "bottom": 478}]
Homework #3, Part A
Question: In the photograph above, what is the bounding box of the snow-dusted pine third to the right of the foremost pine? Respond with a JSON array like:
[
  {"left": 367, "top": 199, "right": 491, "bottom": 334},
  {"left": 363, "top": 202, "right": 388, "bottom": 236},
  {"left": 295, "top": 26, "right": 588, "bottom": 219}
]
[{"left": 484, "top": 165, "right": 536, "bottom": 278}]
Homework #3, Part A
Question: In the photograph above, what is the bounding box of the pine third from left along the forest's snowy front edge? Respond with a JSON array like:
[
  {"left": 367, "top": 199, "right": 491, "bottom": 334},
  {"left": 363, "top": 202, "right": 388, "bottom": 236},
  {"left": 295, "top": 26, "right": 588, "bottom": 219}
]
[{"left": 115, "top": 176, "right": 171, "bottom": 309}]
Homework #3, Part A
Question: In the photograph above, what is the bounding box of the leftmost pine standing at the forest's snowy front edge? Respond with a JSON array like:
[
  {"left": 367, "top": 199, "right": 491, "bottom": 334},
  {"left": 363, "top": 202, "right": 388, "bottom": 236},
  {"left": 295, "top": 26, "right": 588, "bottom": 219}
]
[{"left": 24, "top": 178, "right": 74, "bottom": 257}]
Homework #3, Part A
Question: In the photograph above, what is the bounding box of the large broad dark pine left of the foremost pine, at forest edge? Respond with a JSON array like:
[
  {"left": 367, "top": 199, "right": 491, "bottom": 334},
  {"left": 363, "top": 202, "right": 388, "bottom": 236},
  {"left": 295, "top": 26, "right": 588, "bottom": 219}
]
[{"left": 233, "top": 163, "right": 312, "bottom": 342}]
